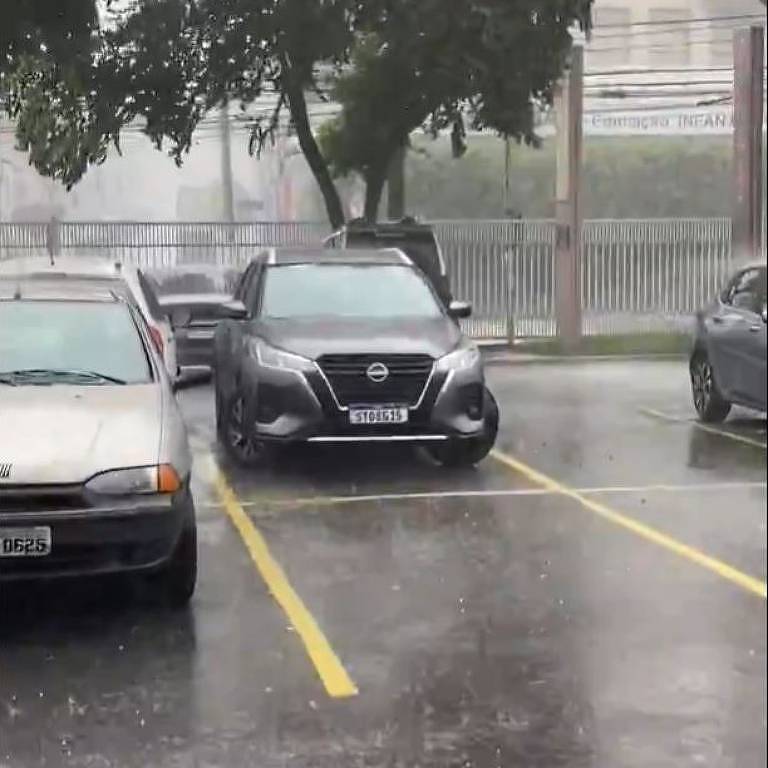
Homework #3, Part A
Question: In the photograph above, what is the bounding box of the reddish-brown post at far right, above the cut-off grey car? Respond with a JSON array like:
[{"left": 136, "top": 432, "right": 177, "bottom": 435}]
[{"left": 731, "top": 25, "right": 765, "bottom": 260}]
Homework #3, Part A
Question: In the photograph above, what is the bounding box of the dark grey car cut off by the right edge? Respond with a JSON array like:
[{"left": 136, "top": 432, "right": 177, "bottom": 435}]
[{"left": 690, "top": 263, "right": 768, "bottom": 422}]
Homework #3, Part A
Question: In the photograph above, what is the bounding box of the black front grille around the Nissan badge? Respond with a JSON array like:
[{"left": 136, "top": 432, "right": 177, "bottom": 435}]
[{"left": 317, "top": 355, "right": 434, "bottom": 406}]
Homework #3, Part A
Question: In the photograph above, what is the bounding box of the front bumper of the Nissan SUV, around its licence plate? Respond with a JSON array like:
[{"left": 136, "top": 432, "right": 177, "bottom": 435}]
[{"left": 244, "top": 359, "right": 486, "bottom": 443}]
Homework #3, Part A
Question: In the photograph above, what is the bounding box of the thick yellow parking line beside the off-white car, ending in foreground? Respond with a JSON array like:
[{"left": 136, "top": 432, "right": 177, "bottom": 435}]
[{"left": 207, "top": 460, "right": 358, "bottom": 699}]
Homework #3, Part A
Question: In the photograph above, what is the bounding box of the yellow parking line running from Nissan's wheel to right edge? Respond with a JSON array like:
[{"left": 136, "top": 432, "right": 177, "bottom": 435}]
[{"left": 491, "top": 450, "right": 766, "bottom": 600}]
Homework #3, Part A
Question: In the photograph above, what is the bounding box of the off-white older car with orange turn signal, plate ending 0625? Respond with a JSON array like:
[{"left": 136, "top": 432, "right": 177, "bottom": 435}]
[{"left": 0, "top": 278, "right": 197, "bottom": 606}]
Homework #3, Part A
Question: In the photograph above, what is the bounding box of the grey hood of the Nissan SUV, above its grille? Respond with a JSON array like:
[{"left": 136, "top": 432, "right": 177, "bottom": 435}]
[{"left": 258, "top": 317, "right": 462, "bottom": 360}]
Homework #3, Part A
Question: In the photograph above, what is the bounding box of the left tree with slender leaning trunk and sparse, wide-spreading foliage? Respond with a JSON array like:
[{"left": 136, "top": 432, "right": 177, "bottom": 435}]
[{"left": 4, "top": 0, "right": 358, "bottom": 225}]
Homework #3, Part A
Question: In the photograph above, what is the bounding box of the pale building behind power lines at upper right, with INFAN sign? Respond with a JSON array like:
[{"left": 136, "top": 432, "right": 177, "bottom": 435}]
[{"left": 572, "top": 0, "right": 766, "bottom": 136}]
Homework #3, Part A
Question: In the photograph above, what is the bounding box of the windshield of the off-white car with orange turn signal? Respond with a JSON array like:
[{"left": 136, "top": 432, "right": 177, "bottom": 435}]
[{"left": 0, "top": 301, "right": 152, "bottom": 384}]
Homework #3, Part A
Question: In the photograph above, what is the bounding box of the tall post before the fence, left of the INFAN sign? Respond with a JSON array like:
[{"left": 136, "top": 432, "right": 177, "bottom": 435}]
[{"left": 555, "top": 46, "right": 584, "bottom": 351}]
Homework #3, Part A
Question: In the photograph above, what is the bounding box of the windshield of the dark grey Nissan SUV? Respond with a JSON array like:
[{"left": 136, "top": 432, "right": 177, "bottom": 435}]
[{"left": 261, "top": 264, "right": 441, "bottom": 319}]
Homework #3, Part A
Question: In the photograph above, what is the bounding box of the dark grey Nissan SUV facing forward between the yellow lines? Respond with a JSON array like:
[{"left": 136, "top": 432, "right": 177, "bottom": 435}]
[{"left": 214, "top": 249, "right": 499, "bottom": 465}]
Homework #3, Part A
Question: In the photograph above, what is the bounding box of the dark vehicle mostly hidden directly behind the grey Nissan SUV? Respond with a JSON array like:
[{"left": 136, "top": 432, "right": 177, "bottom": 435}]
[{"left": 325, "top": 217, "right": 453, "bottom": 308}]
